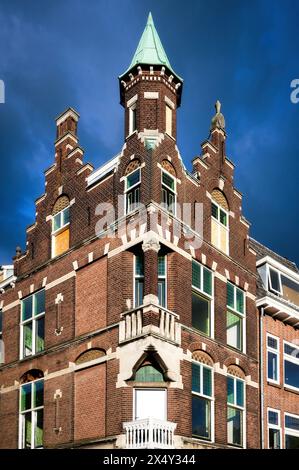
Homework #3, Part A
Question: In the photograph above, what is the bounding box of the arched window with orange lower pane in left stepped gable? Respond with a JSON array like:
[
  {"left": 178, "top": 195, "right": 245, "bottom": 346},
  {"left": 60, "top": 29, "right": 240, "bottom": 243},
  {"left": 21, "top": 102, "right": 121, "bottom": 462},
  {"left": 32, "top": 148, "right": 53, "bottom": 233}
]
[{"left": 52, "top": 196, "right": 70, "bottom": 258}]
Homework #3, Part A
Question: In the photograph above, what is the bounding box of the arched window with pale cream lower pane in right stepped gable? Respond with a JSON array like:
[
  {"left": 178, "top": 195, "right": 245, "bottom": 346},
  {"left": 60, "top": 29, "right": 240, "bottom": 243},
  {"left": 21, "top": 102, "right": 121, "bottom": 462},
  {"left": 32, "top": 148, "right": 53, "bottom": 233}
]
[{"left": 211, "top": 189, "right": 229, "bottom": 254}]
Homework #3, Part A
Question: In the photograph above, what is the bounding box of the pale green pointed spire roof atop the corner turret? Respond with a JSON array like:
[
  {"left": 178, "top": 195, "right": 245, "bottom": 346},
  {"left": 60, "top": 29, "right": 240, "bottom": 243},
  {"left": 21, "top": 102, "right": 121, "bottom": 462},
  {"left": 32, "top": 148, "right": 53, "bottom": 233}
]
[{"left": 121, "top": 13, "right": 182, "bottom": 80}]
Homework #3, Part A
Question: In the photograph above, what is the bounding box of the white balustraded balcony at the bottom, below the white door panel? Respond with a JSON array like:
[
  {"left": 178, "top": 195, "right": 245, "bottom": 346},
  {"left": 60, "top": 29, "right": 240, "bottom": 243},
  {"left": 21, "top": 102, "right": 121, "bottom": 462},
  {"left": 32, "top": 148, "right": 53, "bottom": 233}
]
[{"left": 123, "top": 418, "right": 176, "bottom": 449}]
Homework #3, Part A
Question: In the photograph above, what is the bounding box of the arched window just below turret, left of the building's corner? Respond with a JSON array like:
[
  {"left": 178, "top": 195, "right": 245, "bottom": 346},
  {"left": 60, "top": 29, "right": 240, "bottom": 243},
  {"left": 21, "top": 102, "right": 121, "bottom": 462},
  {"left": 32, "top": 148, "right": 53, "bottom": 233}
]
[{"left": 125, "top": 159, "right": 141, "bottom": 214}]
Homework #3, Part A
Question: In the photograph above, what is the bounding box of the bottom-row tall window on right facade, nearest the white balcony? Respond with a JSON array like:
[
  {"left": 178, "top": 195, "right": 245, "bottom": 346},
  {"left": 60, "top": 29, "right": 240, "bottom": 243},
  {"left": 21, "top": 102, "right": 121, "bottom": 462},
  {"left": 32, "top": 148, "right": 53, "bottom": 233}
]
[{"left": 192, "top": 362, "right": 214, "bottom": 441}]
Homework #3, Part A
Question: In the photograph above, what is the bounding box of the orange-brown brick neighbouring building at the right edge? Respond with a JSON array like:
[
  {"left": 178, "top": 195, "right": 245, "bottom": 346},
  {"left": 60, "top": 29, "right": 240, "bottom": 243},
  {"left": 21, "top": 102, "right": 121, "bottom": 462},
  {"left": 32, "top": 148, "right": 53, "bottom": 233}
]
[{"left": 250, "top": 239, "right": 299, "bottom": 449}]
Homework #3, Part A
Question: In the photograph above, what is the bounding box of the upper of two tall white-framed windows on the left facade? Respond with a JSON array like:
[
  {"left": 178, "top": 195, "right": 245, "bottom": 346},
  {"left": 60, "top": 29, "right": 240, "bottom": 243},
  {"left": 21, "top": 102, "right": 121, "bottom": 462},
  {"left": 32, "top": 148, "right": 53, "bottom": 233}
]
[{"left": 21, "top": 289, "right": 45, "bottom": 359}]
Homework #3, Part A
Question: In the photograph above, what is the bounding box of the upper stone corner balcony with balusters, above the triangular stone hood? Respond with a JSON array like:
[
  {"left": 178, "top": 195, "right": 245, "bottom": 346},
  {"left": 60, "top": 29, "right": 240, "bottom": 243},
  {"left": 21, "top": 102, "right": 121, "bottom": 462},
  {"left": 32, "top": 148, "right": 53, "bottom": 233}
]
[{"left": 119, "top": 304, "right": 181, "bottom": 344}]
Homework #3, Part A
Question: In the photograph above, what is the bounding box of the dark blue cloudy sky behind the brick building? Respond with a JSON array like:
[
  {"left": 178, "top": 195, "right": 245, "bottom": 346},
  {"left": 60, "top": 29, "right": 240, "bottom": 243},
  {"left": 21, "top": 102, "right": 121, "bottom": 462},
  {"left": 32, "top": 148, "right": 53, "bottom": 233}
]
[{"left": 0, "top": 0, "right": 299, "bottom": 264}]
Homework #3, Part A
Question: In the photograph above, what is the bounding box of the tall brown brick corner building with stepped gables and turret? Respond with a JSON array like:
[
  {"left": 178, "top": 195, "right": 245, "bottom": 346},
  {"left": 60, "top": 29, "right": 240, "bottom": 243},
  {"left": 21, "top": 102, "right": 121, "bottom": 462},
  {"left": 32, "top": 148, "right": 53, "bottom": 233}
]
[{"left": 0, "top": 12, "right": 276, "bottom": 448}]
